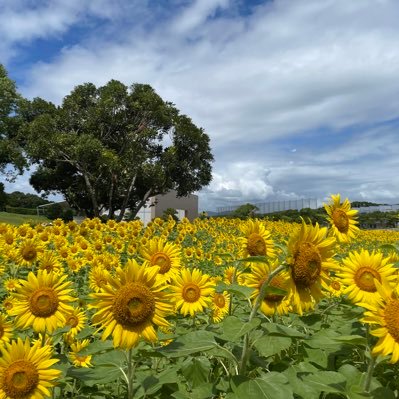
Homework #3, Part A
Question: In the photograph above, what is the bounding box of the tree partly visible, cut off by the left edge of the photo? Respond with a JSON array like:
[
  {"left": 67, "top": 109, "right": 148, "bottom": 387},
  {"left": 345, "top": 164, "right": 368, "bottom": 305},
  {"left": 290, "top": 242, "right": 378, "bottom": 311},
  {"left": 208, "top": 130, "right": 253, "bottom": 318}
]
[{"left": 0, "top": 64, "right": 26, "bottom": 179}]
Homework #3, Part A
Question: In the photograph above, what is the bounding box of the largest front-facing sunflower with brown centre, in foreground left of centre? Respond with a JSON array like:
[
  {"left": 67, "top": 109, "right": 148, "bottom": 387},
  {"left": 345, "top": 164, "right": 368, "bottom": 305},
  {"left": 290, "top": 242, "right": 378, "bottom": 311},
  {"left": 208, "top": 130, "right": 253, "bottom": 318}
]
[{"left": 90, "top": 259, "right": 173, "bottom": 348}]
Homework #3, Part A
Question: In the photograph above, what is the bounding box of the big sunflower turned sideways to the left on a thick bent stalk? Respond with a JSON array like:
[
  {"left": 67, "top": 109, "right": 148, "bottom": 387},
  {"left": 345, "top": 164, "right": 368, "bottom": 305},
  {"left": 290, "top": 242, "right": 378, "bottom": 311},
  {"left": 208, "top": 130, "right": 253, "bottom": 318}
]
[{"left": 287, "top": 220, "right": 336, "bottom": 315}]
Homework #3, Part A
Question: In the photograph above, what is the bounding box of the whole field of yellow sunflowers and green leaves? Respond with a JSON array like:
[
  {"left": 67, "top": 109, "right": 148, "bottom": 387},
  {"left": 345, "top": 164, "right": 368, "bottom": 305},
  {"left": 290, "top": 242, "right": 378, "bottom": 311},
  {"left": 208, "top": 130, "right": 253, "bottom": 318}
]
[{"left": 0, "top": 194, "right": 399, "bottom": 399}]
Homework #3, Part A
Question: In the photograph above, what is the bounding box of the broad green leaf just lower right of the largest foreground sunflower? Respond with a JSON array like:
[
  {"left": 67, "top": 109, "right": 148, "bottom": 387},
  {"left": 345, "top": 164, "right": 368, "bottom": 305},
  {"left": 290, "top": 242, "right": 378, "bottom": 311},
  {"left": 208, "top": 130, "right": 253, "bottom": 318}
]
[{"left": 159, "top": 330, "right": 217, "bottom": 357}]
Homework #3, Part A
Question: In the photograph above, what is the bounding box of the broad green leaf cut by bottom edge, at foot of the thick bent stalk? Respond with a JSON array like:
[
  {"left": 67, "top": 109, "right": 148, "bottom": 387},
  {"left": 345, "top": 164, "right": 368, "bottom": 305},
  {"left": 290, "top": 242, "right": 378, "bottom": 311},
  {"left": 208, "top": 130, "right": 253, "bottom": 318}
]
[{"left": 231, "top": 372, "right": 293, "bottom": 399}]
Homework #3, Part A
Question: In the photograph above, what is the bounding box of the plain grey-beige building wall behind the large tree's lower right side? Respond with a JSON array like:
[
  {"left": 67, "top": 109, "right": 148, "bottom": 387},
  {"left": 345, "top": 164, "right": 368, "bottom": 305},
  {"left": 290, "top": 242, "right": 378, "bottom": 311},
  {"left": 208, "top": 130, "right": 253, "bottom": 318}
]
[{"left": 150, "top": 190, "right": 198, "bottom": 220}]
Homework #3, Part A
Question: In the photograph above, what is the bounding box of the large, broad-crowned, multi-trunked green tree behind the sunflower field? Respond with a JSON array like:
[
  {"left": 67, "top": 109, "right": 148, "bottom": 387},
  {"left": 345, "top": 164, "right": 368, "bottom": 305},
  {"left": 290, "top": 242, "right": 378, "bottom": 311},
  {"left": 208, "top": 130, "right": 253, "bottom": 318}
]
[{"left": 21, "top": 80, "right": 213, "bottom": 219}]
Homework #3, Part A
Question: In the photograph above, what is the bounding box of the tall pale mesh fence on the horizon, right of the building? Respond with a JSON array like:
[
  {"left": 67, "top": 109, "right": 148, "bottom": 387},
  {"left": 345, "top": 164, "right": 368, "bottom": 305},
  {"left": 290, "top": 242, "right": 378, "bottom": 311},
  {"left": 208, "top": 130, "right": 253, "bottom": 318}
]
[{"left": 216, "top": 198, "right": 318, "bottom": 215}]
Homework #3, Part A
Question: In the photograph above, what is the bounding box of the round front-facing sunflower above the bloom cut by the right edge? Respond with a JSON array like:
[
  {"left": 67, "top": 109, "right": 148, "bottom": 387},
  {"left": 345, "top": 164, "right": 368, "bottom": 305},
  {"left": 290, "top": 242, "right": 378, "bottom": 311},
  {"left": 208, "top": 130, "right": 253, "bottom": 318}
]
[{"left": 337, "top": 249, "right": 397, "bottom": 304}]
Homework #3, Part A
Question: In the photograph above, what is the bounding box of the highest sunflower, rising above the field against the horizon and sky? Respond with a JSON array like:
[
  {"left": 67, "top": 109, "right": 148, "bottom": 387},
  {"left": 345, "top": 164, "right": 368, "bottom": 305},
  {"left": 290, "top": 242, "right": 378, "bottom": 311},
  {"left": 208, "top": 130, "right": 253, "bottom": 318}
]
[{"left": 324, "top": 194, "right": 359, "bottom": 242}]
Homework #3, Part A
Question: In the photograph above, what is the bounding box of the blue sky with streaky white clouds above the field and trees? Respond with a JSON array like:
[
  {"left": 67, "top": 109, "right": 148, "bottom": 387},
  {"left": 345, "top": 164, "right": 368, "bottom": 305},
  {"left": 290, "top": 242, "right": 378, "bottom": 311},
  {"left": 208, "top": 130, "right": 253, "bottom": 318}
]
[{"left": 0, "top": 0, "right": 399, "bottom": 210}]
